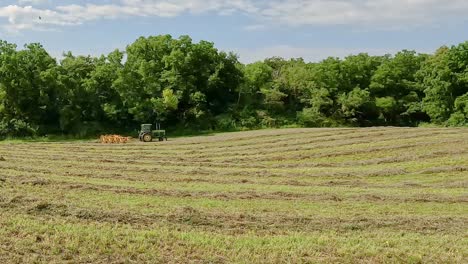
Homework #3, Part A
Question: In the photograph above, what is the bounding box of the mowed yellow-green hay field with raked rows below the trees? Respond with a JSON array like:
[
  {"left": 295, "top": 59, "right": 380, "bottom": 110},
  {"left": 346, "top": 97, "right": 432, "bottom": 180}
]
[{"left": 0, "top": 128, "right": 468, "bottom": 263}]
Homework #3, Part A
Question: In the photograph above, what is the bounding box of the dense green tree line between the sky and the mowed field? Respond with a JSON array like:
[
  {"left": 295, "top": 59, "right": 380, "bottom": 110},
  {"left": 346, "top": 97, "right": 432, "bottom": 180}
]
[{"left": 0, "top": 35, "right": 468, "bottom": 137}]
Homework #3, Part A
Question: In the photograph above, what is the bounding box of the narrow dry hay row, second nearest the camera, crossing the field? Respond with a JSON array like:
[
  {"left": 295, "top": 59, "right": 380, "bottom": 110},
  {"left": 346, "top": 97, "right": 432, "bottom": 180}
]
[{"left": 9, "top": 179, "right": 468, "bottom": 204}]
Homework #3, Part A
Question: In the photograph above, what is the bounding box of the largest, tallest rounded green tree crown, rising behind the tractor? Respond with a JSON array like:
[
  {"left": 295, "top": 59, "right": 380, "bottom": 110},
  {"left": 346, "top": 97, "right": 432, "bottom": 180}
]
[{"left": 113, "top": 35, "right": 242, "bottom": 128}]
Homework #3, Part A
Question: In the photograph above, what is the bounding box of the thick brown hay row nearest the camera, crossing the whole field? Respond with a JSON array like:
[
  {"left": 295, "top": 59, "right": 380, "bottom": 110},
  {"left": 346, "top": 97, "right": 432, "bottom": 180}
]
[{"left": 2, "top": 193, "right": 468, "bottom": 234}]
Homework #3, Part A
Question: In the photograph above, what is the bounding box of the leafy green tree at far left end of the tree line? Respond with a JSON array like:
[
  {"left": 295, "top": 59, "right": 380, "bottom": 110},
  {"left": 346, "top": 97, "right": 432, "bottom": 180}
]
[{"left": 0, "top": 42, "right": 60, "bottom": 135}]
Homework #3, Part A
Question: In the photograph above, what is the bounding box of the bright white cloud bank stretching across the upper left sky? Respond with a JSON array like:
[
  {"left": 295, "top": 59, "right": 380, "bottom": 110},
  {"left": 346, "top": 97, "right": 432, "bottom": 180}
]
[{"left": 0, "top": 0, "right": 257, "bottom": 31}]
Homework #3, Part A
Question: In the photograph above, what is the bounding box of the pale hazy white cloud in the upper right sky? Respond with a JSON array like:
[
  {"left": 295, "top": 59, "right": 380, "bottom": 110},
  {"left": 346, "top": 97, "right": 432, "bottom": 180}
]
[{"left": 261, "top": 0, "right": 468, "bottom": 28}]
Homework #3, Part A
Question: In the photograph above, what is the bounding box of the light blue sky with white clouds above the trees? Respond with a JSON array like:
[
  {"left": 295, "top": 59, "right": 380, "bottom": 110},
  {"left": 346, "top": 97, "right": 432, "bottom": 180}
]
[{"left": 0, "top": 0, "right": 468, "bottom": 62}]
